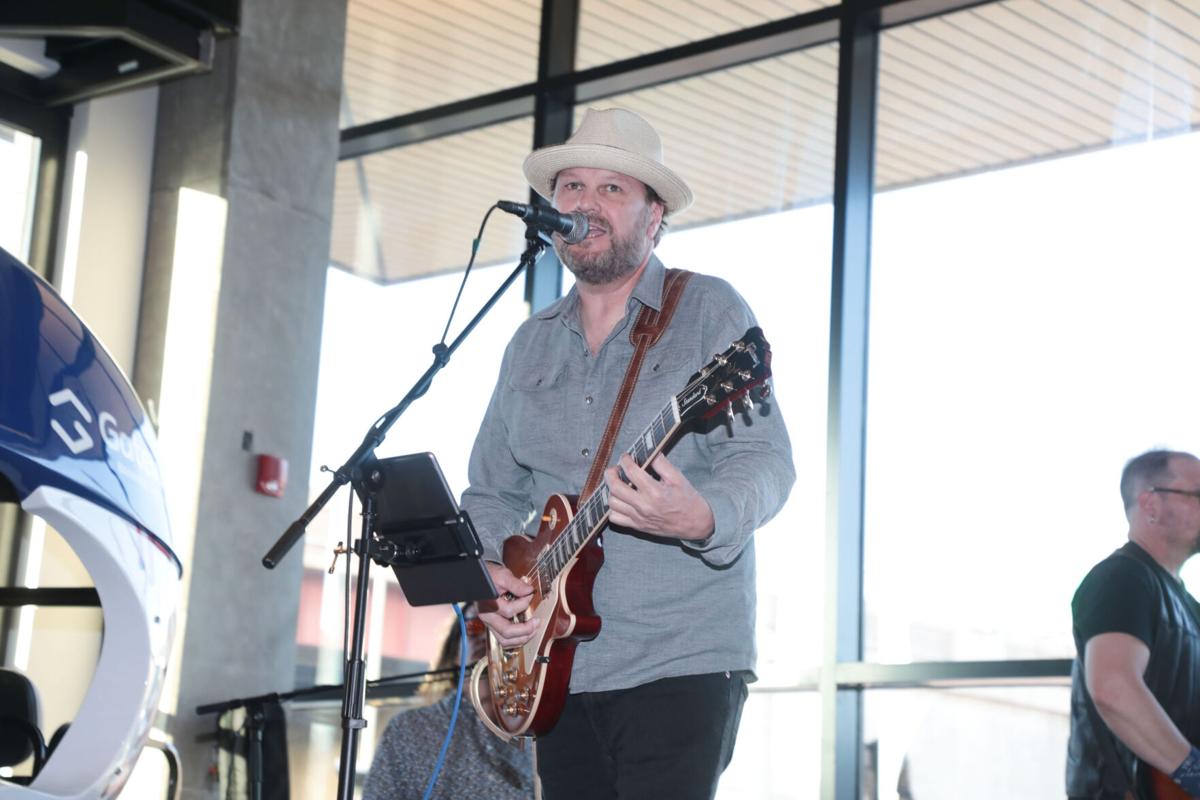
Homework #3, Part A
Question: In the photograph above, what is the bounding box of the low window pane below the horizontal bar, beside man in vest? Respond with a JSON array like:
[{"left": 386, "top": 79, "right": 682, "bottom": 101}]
[{"left": 864, "top": 686, "right": 1070, "bottom": 800}]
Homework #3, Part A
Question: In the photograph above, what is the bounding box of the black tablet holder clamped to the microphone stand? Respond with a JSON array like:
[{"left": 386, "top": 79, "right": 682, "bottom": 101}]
[{"left": 374, "top": 452, "right": 497, "bottom": 606}]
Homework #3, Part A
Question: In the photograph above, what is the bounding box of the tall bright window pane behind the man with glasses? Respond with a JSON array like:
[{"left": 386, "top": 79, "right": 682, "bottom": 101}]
[{"left": 865, "top": 2, "right": 1200, "bottom": 662}]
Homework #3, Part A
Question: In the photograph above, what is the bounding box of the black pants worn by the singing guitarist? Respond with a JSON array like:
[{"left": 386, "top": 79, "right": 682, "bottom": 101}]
[{"left": 538, "top": 673, "right": 746, "bottom": 800}]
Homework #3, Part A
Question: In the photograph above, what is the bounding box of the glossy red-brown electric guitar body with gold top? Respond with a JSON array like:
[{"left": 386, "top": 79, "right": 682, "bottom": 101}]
[{"left": 487, "top": 494, "right": 604, "bottom": 736}]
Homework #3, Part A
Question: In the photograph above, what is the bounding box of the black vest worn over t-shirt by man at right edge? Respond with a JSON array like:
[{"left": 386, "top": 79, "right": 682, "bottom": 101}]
[{"left": 1067, "top": 542, "right": 1200, "bottom": 798}]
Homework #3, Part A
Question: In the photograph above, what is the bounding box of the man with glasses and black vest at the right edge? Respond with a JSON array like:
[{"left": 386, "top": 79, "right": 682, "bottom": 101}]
[{"left": 1067, "top": 450, "right": 1200, "bottom": 800}]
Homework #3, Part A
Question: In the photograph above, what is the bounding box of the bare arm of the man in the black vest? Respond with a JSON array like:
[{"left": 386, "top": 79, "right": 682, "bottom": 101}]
[{"left": 1084, "top": 633, "right": 1192, "bottom": 775}]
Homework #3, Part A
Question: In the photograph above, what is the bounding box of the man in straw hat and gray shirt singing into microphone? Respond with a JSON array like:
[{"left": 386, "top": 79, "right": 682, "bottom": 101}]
[{"left": 463, "top": 108, "right": 794, "bottom": 800}]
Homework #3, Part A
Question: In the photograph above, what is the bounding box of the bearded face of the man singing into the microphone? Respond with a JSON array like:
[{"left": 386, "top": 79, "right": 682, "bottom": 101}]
[{"left": 554, "top": 167, "right": 662, "bottom": 285}]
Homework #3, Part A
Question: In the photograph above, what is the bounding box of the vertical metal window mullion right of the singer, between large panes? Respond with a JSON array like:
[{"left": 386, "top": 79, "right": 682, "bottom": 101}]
[{"left": 821, "top": 8, "right": 880, "bottom": 800}]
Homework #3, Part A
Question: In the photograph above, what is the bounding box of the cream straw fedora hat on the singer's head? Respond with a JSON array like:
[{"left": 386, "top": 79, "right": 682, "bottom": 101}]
[{"left": 524, "top": 108, "right": 692, "bottom": 213}]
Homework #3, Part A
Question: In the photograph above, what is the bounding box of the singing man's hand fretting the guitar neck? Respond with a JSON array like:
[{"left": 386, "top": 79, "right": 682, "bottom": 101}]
[{"left": 604, "top": 453, "right": 716, "bottom": 541}]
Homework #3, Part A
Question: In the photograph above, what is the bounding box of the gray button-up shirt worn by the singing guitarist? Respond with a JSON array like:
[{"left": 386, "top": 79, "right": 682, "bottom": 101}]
[{"left": 462, "top": 257, "right": 796, "bottom": 692}]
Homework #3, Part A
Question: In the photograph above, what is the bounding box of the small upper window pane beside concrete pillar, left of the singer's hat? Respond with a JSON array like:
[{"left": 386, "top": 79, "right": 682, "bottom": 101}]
[{"left": 342, "top": 0, "right": 541, "bottom": 127}]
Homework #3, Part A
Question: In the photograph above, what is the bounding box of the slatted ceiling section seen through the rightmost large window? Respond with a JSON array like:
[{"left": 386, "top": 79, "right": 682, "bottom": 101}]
[{"left": 876, "top": 0, "right": 1200, "bottom": 190}]
